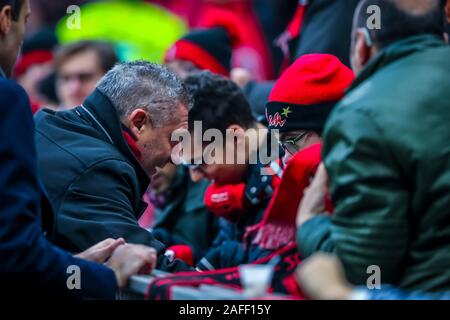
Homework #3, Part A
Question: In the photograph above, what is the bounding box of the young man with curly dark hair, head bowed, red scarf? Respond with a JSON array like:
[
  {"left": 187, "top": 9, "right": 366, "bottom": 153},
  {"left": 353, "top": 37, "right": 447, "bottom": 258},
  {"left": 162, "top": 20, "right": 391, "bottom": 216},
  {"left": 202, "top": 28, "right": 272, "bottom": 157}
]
[{"left": 185, "top": 71, "right": 281, "bottom": 270}]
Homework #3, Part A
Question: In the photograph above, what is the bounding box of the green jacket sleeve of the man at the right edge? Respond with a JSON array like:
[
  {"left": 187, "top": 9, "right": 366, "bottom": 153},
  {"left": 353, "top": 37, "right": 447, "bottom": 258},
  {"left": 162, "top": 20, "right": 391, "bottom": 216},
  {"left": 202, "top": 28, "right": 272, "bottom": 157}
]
[{"left": 323, "top": 105, "right": 410, "bottom": 284}]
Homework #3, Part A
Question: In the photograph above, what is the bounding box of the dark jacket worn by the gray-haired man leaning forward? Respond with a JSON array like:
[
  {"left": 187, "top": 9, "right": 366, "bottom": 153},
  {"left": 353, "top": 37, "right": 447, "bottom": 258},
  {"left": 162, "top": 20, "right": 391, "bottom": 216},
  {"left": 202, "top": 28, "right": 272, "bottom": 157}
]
[{"left": 35, "top": 90, "right": 191, "bottom": 271}]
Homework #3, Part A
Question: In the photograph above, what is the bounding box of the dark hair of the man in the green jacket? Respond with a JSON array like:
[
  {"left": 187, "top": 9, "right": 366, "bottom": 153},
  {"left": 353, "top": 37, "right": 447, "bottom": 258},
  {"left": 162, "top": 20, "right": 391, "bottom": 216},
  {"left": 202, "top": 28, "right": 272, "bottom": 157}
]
[{"left": 354, "top": 0, "right": 446, "bottom": 49}]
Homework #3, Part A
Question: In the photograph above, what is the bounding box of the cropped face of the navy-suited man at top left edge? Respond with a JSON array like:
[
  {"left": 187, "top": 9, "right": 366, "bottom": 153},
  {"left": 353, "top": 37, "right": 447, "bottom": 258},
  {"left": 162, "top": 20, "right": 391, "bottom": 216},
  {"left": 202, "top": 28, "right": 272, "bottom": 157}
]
[{"left": 0, "top": 0, "right": 31, "bottom": 77}]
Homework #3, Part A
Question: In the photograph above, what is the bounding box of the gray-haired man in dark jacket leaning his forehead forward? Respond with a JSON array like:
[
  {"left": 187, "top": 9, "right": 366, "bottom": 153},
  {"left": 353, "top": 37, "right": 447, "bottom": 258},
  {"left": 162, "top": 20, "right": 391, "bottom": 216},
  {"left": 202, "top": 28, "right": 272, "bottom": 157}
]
[{"left": 35, "top": 61, "right": 190, "bottom": 271}]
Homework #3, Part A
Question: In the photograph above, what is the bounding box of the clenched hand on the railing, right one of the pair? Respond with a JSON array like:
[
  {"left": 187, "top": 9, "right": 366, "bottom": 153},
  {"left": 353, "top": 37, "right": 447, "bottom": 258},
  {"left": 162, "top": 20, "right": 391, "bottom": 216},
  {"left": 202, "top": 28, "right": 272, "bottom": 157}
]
[{"left": 106, "top": 244, "right": 157, "bottom": 288}]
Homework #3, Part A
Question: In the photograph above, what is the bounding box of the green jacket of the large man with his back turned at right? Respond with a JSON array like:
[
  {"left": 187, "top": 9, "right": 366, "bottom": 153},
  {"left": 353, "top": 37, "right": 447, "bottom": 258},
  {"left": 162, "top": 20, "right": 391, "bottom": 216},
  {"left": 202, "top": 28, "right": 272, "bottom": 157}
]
[{"left": 297, "top": 35, "right": 450, "bottom": 291}]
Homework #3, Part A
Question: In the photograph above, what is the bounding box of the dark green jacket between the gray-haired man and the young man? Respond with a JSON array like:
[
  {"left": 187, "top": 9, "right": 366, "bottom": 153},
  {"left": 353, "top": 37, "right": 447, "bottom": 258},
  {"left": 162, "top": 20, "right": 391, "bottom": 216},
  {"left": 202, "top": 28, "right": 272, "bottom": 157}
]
[{"left": 153, "top": 166, "right": 219, "bottom": 259}]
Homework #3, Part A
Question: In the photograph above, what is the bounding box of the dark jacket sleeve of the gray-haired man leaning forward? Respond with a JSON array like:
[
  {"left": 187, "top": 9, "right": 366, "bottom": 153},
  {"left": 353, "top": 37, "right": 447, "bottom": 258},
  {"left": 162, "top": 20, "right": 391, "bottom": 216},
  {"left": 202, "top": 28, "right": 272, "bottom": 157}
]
[{"left": 57, "top": 160, "right": 164, "bottom": 253}]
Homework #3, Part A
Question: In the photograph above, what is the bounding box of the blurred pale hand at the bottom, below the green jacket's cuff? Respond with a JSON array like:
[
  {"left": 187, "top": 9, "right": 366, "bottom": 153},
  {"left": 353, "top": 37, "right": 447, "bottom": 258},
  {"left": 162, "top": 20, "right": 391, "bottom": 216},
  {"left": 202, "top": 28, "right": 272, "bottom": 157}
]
[{"left": 295, "top": 253, "right": 353, "bottom": 300}]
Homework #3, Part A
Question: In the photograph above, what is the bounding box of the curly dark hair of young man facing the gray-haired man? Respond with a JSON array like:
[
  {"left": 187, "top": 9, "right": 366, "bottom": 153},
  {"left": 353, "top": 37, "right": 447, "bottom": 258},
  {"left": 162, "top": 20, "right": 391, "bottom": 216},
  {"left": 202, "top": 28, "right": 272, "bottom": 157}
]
[{"left": 185, "top": 71, "right": 256, "bottom": 133}]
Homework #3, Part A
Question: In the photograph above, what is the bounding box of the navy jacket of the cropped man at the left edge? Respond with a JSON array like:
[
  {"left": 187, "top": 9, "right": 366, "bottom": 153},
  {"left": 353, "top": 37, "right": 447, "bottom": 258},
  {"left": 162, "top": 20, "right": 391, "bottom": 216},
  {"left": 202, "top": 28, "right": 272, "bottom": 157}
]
[{"left": 0, "top": 79, "right": 116, "bottom": 299}]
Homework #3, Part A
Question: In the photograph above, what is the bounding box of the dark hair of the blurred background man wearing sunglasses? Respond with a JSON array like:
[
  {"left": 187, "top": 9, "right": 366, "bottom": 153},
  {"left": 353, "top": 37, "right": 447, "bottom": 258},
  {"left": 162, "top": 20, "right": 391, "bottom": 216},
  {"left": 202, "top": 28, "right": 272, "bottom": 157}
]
[{"left": 55, "top": 40, "right": 118, "bottom": 73}]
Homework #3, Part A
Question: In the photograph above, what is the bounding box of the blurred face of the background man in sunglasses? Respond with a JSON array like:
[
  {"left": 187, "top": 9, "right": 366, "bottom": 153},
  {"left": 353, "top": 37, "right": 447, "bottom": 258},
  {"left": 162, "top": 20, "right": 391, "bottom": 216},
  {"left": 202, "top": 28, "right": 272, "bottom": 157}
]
[{"left": 56, "top": 50, "right": 105, "bottom": 108}]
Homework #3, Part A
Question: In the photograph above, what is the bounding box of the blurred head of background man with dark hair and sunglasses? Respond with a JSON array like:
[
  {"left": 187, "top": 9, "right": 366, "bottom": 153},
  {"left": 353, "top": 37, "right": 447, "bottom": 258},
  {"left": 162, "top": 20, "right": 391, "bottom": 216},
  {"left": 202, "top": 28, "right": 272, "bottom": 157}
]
[{"left": 55, "top": 40, "right": 118, "bottom": 109}]
